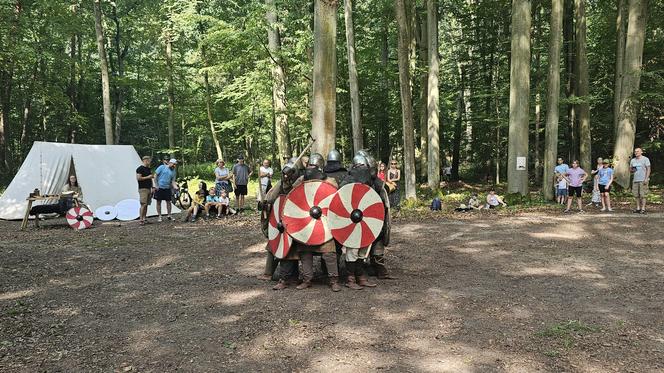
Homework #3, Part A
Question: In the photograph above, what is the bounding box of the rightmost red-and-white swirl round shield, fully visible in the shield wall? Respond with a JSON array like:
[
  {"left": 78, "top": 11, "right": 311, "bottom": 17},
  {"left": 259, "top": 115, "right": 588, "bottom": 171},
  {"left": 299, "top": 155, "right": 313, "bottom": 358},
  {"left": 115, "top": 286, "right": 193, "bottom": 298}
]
[{"left": 327, "top": 183, "right": 385, "bottom": 249}]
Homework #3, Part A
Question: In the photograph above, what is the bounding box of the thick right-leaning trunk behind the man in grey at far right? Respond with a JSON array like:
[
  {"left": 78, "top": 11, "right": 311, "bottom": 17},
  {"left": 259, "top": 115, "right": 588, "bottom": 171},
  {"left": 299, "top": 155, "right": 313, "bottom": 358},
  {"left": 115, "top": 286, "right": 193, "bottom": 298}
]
[{"left": 613, "top": 0, "right": 648, "bottom": 187}]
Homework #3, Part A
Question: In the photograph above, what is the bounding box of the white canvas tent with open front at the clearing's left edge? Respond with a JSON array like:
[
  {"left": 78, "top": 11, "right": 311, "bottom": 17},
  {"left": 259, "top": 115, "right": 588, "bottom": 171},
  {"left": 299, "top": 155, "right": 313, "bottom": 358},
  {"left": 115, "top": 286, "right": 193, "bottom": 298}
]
[{"left": 0, "top": 141, "right": 179, "bottom": 220}]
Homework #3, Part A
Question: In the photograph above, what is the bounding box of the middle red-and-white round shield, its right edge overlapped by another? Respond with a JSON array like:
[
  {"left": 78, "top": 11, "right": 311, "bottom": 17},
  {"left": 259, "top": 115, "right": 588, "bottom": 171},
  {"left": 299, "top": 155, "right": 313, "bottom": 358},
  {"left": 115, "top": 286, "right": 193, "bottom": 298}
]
[{"left": 282, "top": 180, "right": 337, "bottom": 246}]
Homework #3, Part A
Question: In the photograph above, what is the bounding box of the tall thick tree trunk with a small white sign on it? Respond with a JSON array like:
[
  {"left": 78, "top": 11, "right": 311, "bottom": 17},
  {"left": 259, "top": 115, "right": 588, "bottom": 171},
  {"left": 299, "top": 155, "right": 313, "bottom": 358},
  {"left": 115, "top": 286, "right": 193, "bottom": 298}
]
[{"left": 507, "top": 0, "right": 531, "bottom": 195}]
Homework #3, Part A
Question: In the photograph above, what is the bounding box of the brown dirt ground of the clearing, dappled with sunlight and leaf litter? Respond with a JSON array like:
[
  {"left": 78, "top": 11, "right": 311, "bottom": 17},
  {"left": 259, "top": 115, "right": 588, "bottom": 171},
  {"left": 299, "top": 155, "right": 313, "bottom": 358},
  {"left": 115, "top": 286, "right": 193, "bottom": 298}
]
[{"left": 0, "top": 209, "right": 664, "bottom": 372}]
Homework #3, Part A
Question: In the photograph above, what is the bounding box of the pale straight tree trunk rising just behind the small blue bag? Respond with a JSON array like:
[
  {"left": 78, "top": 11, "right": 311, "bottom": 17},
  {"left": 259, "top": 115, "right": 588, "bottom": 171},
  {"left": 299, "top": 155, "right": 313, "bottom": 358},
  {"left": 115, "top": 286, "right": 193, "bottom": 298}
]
[{"left": 427, "top": 0, "right": 440, "bottom": 189}]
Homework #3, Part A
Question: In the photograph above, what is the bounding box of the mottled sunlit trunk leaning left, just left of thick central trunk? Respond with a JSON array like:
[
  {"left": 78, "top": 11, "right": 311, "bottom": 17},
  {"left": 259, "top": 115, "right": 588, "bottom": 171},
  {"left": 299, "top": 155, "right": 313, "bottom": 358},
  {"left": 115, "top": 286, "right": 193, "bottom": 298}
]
[{"left": 265, "top": 0, "right": 293, "bottom": 164}]
